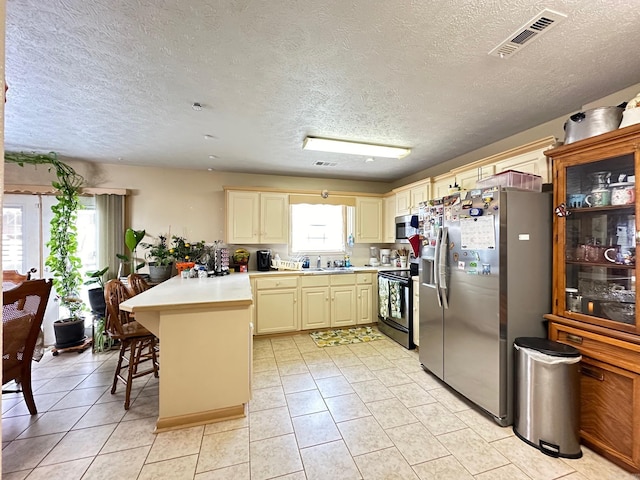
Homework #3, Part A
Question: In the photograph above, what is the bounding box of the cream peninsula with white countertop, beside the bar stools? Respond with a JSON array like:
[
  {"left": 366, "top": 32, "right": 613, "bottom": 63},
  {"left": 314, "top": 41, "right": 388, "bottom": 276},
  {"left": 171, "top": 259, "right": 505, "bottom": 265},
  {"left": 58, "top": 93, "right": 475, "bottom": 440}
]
[{"left": 120, "top": 273, "right": 253, "bottom": 432}]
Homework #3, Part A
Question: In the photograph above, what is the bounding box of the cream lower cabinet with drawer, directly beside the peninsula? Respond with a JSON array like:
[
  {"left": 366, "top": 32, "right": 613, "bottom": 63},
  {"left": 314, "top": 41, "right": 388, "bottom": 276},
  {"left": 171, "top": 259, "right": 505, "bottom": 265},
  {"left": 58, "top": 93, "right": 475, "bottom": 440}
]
[{"left": 254, "top": 276, "right": 300, "bottom": 334}]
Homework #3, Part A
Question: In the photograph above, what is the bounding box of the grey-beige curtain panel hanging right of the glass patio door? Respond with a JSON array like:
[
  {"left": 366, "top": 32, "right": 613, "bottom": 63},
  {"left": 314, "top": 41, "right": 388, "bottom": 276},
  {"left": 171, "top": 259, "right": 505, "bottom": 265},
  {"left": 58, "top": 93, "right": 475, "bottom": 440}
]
[{"left": 95, "top": 194, "right": 125, "bottom": 278}]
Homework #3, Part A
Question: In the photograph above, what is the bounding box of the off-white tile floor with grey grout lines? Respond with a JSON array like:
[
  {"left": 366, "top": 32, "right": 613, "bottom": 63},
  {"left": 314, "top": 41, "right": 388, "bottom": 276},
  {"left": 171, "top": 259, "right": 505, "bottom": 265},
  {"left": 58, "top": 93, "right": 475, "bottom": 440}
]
[{"left": 2, "top": 334, "right": 637, "bottom": 480}]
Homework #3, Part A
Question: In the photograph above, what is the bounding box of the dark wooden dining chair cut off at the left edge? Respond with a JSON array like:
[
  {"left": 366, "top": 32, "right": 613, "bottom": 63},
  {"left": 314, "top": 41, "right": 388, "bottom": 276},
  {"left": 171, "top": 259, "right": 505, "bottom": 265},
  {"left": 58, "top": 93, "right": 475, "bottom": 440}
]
[{"left": 2, "top": 280, "right": 52, "bottom": 415}]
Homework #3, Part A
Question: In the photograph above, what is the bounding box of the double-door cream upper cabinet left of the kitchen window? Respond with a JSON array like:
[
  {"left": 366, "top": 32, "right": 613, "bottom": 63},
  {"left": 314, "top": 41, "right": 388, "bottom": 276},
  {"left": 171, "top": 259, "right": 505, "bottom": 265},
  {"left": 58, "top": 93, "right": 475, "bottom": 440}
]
[{"left": 226, "top": 190, "right": 289, "bottom": 244}]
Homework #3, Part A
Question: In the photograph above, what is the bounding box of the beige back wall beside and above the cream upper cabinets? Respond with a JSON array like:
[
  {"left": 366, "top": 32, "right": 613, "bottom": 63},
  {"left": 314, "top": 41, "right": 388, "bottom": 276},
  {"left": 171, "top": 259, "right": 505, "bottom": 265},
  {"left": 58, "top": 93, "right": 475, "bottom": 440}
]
[{"left": 5, "top": 162, "right": 390, "bottom": 242}]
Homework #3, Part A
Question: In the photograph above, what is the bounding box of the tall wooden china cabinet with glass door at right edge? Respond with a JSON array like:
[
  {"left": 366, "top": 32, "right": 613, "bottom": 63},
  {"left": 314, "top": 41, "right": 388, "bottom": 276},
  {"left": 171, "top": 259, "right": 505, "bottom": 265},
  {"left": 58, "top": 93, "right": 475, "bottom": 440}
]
[{"left": 545, "top": 125, "right": 640, "bottom": 472}]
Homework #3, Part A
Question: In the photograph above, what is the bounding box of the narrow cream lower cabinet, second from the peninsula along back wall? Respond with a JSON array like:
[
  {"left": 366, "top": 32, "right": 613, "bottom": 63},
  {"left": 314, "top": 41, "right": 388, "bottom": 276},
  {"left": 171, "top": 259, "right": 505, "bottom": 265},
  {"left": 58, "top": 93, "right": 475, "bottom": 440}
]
[{"left": 300, "top": 275, "right": 331, "bottom": 330}]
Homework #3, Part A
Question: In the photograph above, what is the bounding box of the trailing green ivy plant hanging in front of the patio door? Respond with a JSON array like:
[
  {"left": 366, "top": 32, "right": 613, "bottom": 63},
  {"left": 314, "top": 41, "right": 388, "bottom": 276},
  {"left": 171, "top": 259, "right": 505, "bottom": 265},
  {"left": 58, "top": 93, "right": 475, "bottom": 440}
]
[{"left": 4, "top": 152, "right": 84, "bottom": 320}]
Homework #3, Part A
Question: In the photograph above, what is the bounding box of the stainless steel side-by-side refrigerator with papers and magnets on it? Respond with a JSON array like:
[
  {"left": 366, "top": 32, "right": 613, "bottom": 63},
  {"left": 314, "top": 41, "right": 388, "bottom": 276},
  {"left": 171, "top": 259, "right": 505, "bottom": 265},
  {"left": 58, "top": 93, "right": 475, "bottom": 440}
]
[{"left": 419, "top": 187, "right": 553, "bottom": 426}]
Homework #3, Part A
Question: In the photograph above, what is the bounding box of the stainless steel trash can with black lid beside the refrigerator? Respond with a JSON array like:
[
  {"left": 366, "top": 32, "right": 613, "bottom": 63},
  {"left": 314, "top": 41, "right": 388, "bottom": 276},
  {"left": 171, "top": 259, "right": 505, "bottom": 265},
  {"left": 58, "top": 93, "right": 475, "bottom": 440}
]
[{"left": 513, "top": 337, "right": 582, "bottom": 458}]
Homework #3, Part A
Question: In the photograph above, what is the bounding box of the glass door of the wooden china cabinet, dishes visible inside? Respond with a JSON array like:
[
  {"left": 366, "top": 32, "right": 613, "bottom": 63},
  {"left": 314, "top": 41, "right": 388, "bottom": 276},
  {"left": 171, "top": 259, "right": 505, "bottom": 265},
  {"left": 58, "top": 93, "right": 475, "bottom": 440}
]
[{"left": 564, "top": 154, "right": 636, "bottom": 331}]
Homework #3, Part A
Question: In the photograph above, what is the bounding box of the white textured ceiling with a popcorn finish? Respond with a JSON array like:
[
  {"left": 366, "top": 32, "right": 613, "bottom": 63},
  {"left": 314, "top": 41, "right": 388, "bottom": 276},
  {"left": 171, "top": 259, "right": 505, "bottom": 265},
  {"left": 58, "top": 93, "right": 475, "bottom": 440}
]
[{"left": 5, "top": 0, "right": 640, "bottom": 181}]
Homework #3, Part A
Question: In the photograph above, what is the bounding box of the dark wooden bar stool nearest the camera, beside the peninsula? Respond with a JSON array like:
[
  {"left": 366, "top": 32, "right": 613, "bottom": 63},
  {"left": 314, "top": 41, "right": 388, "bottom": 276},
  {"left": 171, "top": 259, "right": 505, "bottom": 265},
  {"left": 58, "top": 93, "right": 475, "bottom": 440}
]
[{"left": 104, "top": 279, "right": 159, "bottom": 410}]
